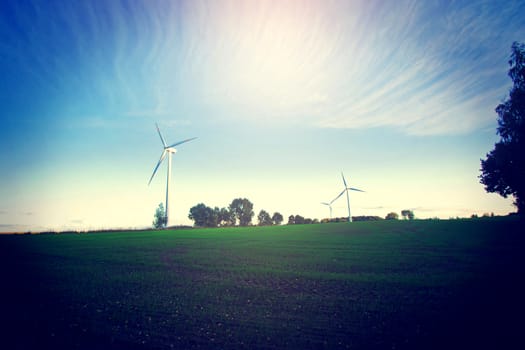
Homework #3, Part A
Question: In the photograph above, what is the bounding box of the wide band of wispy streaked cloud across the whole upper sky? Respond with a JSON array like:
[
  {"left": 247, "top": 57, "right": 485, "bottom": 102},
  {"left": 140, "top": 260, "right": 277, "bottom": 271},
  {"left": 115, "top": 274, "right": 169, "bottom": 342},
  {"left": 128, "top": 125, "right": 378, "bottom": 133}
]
[{"left": 1, "top": 1, "right": 525, "bottom": 135}]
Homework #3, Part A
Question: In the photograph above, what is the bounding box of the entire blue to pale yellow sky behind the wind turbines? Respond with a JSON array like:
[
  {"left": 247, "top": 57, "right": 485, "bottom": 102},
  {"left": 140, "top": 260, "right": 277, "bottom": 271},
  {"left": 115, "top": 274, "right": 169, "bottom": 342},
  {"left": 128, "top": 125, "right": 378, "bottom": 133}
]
[{"left": 0, "top": 0, "right": 525, "bottom": 232}]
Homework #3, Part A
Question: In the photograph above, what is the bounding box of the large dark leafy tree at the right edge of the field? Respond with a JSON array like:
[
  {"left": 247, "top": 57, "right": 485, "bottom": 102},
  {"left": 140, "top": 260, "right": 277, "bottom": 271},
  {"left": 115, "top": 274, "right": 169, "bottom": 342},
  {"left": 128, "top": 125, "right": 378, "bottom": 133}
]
[{"left": 479, "top": 42, "right": 525, "bottom": 215}]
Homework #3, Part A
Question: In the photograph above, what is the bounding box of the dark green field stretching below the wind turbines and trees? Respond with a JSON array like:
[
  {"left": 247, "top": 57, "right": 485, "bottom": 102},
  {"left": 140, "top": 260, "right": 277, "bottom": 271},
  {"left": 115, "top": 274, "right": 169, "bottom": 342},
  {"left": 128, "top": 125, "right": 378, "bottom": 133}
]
[{"left": 0, "top": 218, "right": 525, "bottom": 349}]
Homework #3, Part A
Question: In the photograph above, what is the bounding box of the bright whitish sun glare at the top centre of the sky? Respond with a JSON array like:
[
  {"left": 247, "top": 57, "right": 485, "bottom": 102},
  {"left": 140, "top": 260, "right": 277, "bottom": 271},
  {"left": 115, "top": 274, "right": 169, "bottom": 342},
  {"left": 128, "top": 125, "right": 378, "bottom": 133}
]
[{"left": 199, "top": 3, "right": 338, "bottom": 118}]
